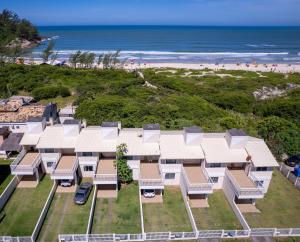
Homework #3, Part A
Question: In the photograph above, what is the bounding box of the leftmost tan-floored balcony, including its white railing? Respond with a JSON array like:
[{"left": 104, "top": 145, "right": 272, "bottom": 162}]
[{"left": 10, "top": 150, "right": 41, "bottom": 175}]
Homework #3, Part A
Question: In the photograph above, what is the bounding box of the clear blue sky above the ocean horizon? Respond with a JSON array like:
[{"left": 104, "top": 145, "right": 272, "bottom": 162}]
[{"left": 0, "top": 0, "right": 300, "bottom": 26}]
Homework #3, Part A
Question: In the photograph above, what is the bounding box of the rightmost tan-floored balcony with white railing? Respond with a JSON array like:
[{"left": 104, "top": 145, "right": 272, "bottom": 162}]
[{"left": 225, "top": 169, "right": 264, "bottom": 199}]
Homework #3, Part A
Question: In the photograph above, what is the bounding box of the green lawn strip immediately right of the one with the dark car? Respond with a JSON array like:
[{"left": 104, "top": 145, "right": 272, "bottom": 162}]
[{"left": 92, "top": 183, "right": 142, "bottom": 234}]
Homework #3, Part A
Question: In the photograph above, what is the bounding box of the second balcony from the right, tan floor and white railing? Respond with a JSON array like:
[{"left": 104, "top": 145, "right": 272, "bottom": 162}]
[{"left": 182, "top": 165, "right": 213, "bottom": 194}]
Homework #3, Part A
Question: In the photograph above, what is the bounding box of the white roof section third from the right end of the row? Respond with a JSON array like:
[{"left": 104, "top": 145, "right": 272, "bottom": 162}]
[{"left": 160, "top": 131, "right": 205, "bottom": 159}]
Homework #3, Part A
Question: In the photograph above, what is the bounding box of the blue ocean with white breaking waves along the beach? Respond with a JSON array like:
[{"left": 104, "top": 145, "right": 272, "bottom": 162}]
[{"left": 32, "top": 26, "right": 300, "bottom": 64}]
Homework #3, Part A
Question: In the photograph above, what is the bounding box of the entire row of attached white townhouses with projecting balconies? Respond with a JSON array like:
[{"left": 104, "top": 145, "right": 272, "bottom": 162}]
[{"left": 12, "top": 119, "right": 278, "bottom": 207}]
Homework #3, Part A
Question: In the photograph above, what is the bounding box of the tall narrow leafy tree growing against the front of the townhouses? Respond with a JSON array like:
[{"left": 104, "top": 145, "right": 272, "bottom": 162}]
[{"left": 115, "top": 144, "right": 133, "bottom": 184}]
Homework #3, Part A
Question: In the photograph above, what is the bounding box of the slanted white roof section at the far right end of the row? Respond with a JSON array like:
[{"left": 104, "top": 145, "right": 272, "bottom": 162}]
[{"left": 246, "top": 138, "right": 279, "bottom": 167}]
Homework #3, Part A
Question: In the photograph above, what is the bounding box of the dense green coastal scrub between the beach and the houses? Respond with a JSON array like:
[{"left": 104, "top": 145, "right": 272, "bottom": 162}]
[{"left": 0, "top": 64, "right": 300, "bottom": 157}]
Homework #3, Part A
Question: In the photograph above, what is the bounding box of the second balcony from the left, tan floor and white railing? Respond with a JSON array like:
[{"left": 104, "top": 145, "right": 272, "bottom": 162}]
[{"left": 51, "top": 155, "right": 78, "bottom": 180}]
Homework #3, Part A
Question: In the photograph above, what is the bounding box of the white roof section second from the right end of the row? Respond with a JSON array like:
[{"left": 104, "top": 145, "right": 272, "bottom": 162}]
[{"left": 201, "top": 136, "right": 248, "bottom": 163}]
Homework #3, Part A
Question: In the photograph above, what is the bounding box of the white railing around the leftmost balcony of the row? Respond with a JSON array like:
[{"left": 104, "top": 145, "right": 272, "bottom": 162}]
[{"left": 10, "top": 150, "right": 41, "bottom": 174}]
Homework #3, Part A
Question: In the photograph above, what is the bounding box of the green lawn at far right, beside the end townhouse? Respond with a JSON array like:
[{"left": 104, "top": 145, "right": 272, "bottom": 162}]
[{"left": 244, "top": 170, "right": 300, "bottom": 228}]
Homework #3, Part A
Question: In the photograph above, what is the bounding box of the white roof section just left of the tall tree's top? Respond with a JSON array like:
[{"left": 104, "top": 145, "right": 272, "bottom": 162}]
[{"left": 75, "top": 126, "right": 117, "bottom": 152}]
